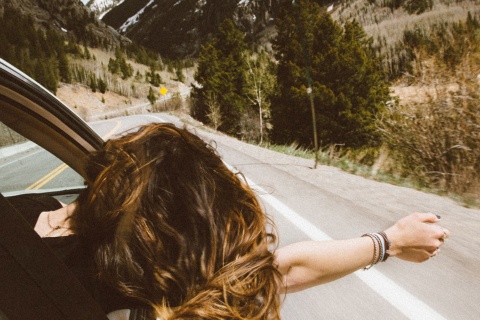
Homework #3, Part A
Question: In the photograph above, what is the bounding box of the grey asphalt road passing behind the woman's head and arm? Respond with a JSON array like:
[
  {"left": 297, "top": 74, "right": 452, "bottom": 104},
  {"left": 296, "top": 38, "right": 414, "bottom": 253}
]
[{"left": 0, "top": 115, "right": 480, "bottom": 320}]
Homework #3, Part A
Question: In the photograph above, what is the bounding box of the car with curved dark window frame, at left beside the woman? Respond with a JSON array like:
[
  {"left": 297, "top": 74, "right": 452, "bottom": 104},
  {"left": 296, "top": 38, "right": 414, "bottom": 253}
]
[{"left": 0, "top": 59, "right": 113, "bottom": 320}]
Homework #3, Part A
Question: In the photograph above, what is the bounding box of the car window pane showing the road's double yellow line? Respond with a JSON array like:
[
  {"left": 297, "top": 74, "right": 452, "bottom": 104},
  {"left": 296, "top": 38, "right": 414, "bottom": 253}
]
[{"left": 0, "top": 122, "right": 84, "bottom": 195}]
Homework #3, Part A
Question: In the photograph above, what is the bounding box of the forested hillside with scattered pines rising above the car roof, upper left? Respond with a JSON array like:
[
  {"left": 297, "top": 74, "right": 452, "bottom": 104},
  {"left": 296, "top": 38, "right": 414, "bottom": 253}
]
[{"left": 0, "top": 0, "right": 192, "bottom": 109}]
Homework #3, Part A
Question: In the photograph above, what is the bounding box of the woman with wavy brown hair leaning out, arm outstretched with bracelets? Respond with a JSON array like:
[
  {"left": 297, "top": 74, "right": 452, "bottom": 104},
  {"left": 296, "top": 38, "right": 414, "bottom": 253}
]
[{"left": 16, "top": 124, "right": 449, "bottom": 319}]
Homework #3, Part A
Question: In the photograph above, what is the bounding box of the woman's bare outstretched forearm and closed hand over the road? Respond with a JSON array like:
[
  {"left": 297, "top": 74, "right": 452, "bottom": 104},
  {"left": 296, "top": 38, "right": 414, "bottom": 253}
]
[{"left": 275, "top": 213, "right": 450, "bottom": 293}]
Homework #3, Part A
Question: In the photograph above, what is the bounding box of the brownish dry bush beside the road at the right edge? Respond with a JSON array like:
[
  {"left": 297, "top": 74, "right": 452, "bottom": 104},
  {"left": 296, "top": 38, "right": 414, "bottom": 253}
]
[{"left": 380, "top": 82, "right": 480, "bottom": 194}]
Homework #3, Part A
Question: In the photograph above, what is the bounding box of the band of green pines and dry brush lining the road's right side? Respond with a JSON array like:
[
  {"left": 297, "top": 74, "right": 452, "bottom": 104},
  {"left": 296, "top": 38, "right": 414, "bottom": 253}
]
[{"left": 191, "top": 0, "right": 480, "bottom": 205}]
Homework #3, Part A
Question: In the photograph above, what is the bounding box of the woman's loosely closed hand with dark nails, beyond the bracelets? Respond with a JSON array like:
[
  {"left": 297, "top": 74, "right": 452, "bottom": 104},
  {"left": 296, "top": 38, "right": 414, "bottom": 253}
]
[{"left": 385, "top": 213, "right": 450, "bottom": 262}]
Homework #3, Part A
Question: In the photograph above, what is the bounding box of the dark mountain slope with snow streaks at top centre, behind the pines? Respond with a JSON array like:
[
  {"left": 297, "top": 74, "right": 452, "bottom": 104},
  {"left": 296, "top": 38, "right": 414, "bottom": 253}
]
[{"left": 102, "top": 0, "right": 281, "bottom": 58}]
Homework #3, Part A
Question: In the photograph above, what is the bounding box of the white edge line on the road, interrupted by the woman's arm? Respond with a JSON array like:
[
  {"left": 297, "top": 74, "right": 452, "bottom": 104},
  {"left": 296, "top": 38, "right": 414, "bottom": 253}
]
[{"left": 226, "top": 164, "right": 446, "bottom": 320}]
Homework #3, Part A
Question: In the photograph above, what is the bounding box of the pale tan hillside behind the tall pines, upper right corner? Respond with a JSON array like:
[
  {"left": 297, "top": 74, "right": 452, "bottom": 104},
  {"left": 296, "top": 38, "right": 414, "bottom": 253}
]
[{"left": 332, "top": 0, "right": 480, "bottom": 79}]
